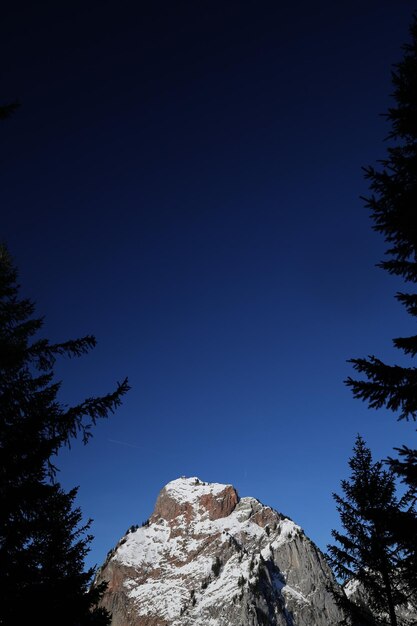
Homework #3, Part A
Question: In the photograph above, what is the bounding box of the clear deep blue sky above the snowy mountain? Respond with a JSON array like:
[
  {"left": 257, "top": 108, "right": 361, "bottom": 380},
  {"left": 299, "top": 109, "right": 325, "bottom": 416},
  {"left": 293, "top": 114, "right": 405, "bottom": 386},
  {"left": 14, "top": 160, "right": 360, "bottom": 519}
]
[{"left": 0, "top": 0, "right": 416, "bottom": 564}]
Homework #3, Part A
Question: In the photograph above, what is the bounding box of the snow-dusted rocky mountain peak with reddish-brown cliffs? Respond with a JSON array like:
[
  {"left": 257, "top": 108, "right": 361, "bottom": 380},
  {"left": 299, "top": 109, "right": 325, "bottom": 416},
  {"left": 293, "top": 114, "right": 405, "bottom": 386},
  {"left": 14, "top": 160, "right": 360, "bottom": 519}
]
[{"left": 98, "top": 478, "right": 343, "bottom": 626}]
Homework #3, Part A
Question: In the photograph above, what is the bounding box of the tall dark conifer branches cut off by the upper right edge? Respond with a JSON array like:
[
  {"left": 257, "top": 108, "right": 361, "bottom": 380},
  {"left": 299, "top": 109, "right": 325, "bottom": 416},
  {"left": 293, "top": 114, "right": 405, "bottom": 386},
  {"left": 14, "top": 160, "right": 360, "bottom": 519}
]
[{"left": 346, "top": 15, "right": 417, "bottom": 478}]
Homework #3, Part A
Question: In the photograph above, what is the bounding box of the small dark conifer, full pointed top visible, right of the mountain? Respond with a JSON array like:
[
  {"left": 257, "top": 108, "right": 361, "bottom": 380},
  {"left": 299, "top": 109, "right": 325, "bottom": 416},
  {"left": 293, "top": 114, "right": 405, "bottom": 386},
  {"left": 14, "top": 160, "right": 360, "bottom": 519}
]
[{"left": 327, "top": 435, "right": 417, "bottom": 626}]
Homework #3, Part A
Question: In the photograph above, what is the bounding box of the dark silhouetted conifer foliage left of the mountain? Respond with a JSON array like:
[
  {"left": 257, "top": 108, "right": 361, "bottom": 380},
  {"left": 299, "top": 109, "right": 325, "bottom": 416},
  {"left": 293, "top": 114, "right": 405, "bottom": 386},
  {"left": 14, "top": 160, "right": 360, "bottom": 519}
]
[{"left": 0, "top": 247, "right": 128, "bottom": 626}]
